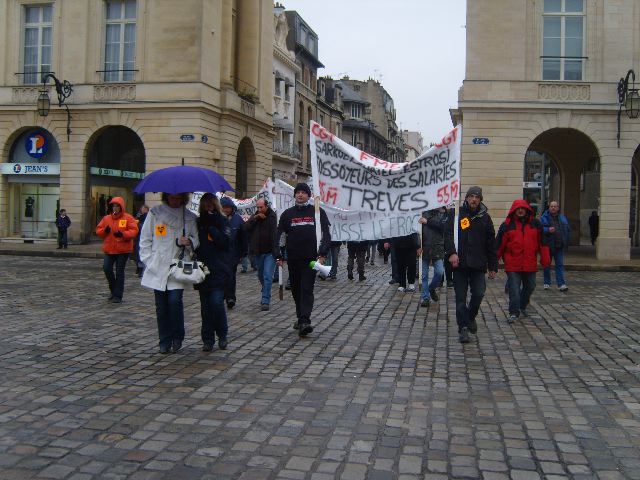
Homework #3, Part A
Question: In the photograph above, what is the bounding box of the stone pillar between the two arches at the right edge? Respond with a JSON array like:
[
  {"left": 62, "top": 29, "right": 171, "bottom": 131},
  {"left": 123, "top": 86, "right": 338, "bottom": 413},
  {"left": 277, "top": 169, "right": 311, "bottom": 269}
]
[{"left": 596, "top": 147, "right": 633, "bottom": 260}]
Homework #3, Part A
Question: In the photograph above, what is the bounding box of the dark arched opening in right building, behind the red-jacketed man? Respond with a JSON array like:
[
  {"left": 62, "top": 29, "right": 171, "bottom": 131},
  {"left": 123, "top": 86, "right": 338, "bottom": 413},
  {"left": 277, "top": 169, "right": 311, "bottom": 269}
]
[{"left": 524, "top": 128, "right": 600, "bottom": 245}]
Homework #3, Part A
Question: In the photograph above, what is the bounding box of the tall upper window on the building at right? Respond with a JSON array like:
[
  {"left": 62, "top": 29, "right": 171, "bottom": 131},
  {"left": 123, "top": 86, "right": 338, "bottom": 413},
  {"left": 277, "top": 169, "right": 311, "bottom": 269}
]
[{"left": 542, "top": 0, "right": 585, "bottom": 81}]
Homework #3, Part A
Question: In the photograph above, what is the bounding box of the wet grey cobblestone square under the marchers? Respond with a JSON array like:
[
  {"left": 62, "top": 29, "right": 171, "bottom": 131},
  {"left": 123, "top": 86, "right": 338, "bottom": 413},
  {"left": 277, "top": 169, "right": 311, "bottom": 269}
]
[{"left": 0, "top": 256, "right": 640, "bottom": 480}]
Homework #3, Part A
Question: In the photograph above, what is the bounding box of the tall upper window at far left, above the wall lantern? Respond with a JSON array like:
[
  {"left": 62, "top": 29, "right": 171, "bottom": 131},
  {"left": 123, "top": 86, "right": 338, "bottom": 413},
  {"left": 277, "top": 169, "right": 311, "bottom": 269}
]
[{"left": 22, "top": 5, "right": 53, "bottom": 84}]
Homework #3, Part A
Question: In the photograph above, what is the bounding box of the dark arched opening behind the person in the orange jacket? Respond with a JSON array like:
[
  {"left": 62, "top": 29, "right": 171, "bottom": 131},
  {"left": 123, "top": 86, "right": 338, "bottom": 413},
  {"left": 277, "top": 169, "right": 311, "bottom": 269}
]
[{"left": 86, "top": 125, "right": 146, "bottom": 232}]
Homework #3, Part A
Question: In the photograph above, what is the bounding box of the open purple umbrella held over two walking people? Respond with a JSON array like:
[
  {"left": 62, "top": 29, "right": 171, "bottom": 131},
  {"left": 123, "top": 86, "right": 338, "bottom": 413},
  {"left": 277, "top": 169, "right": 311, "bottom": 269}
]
[{"left": 133, "top": 165, "right": 234, "bottom": 194}]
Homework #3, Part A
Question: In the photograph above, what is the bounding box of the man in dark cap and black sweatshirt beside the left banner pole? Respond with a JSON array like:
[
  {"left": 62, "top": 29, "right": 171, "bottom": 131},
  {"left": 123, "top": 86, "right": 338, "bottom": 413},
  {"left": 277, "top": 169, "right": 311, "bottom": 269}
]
[{"left": 277, "top": 183, "right": 331, "bottom": 337}]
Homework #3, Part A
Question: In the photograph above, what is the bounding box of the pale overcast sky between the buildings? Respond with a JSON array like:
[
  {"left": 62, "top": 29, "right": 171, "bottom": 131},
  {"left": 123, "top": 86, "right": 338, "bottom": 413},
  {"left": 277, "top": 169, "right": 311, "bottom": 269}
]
[{"left": 283, "top": 0, "right": 466, "bottom": 147}]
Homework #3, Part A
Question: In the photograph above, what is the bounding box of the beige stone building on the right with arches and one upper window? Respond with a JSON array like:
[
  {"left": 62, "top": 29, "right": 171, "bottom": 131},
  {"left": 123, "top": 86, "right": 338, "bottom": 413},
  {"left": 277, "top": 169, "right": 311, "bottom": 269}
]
[{"left": 452, "top": 0, "right": 640, "bottom": 260}]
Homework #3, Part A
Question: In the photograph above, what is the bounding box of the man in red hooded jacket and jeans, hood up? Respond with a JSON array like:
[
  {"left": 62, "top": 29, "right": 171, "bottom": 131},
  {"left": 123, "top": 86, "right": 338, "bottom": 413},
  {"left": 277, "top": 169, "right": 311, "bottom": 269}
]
[{"left": 496, "top": 199, "right": 550, "bottom": 323}]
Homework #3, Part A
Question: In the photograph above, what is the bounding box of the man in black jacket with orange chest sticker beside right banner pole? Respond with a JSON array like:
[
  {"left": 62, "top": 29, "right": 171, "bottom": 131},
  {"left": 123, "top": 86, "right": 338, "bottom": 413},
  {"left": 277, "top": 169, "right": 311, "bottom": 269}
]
[{"left": 445, "top": 187, "right": 498, "bottom": 343}]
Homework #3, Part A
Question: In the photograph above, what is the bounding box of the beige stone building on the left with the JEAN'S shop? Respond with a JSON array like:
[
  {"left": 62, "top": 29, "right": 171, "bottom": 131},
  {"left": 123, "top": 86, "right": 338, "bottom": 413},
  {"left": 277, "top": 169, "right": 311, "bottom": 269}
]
[{"left": 0, "top": 0, "right": 274, "bottom": 242}]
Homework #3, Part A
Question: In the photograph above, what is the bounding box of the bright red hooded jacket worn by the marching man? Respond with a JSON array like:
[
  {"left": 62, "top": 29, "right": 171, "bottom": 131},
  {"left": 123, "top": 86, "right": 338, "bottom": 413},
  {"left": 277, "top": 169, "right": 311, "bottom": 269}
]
[{"left": 496, "top": 200, "right": 551, "bottom": 272}]
